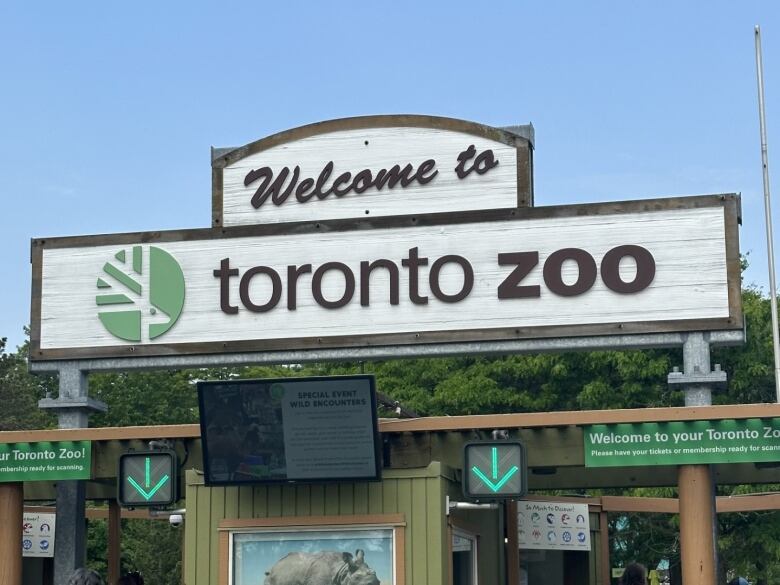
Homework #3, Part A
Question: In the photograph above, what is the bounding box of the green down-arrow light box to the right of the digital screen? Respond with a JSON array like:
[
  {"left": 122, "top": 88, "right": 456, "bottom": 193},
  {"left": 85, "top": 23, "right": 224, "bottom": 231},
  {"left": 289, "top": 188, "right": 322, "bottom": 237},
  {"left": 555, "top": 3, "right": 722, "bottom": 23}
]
[{"left": 463, "top": 441, "right": 528, "bottom": 501}]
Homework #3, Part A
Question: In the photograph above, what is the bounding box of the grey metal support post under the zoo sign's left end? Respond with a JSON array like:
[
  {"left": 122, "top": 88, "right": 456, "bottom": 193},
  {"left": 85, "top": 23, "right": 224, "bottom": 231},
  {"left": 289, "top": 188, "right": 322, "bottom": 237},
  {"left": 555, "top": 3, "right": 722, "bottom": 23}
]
[{"left": 38, "top": 362, "right": 107, "bottom": 585}]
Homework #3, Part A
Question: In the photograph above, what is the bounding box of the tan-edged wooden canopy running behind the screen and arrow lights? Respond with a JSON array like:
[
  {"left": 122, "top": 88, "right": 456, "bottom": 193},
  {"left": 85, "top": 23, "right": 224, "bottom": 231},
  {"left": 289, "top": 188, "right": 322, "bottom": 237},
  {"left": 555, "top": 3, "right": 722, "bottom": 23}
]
[{"left": 0, "top": 404, "right": 780, "bottom": 501}]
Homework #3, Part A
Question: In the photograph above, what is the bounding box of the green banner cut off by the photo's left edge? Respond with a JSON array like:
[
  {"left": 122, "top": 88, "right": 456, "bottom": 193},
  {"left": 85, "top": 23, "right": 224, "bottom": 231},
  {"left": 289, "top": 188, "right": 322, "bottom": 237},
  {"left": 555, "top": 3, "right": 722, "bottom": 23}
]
[{"left": 0, "top": 441, "right": 92, "bottom": 482}]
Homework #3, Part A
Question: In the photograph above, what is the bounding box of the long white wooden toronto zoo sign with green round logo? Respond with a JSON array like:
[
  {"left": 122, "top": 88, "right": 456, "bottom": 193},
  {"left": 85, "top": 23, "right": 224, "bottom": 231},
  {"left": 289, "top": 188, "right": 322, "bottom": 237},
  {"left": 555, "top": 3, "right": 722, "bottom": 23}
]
[{"left": 32, "top": 197, "right": 741, "bottom": 359}]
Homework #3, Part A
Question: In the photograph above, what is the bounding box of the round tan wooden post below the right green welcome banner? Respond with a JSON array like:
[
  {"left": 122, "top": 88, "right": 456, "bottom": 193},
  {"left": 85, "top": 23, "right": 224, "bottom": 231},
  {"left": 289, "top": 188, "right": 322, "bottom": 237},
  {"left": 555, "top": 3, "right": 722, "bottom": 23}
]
[{"left": 677, "top": 465, "right": 716, "bottom": 585}]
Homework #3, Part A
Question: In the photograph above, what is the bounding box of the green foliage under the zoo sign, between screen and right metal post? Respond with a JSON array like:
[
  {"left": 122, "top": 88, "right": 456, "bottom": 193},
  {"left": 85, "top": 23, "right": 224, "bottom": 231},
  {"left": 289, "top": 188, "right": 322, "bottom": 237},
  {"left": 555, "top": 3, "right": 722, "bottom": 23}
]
[{"left": 288, "top": 350, "right": 682, "bottom": 416}]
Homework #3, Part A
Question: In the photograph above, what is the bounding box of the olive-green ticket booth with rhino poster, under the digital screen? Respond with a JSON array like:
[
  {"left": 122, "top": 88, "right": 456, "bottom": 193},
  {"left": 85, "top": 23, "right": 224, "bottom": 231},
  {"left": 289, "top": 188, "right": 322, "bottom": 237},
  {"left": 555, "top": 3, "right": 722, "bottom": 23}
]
[{"left": 185, "top": 462, "right": 458, "bottom": 585}]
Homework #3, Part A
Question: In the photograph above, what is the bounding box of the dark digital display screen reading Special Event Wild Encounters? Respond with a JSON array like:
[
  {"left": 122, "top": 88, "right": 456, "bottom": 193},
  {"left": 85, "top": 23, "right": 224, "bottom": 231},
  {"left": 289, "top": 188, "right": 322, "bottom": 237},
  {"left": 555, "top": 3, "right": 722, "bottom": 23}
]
[{"left": 198, "top": 376, "right": 381, "bottom": 485}]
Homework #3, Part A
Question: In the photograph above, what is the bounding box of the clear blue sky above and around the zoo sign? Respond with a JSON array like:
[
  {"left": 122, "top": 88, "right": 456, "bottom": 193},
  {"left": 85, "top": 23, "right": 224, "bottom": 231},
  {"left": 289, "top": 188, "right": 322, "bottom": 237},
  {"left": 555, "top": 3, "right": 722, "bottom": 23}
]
[{"left": 0, "top": 0, "right": 780, "bottom": 348}]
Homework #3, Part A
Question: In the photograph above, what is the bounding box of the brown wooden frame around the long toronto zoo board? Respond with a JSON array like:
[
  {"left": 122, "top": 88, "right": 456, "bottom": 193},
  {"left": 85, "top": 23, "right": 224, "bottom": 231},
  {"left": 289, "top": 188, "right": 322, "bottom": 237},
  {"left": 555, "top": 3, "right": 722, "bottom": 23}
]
[{"left": 30, "top": 195, "right": 743, "bottom": 361}]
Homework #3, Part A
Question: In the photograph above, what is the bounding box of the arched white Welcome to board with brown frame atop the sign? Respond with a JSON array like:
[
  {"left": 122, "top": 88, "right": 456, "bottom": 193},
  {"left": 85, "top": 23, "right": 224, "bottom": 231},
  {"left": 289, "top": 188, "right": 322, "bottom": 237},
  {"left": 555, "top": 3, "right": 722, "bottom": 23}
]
[{"left": 212, "top": 115, "right": 533, "bottom": 227}]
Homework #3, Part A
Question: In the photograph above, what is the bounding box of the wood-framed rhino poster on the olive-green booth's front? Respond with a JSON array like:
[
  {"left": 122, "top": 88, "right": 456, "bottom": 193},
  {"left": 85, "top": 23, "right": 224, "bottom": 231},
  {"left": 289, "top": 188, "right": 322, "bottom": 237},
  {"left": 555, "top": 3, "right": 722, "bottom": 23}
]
[{"left": 220, "top": 515, "right": 404, "bottom": 585}]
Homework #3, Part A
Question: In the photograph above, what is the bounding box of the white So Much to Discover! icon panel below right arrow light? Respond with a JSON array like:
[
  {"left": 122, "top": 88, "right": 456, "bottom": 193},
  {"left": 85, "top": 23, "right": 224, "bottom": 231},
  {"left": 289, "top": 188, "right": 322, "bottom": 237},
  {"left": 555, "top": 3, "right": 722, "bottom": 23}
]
[{"left": 517, "top": 500, "right": 590, "bottom": 550}]
